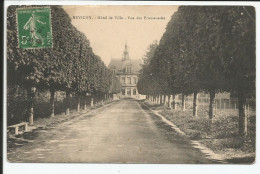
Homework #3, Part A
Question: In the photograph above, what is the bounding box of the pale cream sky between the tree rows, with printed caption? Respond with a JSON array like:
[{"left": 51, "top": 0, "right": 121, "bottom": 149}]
[{"left": 63, "top": 6, "right": 178, "bottom": 65}]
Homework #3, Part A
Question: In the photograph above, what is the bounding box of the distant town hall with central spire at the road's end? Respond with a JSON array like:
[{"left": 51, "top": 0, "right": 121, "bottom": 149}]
[{"left": 108, "top": 44, "right": 141, "bottom": 98}]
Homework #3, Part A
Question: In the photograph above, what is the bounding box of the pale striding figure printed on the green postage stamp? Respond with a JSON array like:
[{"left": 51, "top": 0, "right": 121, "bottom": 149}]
[{"left": 23, "top": 11, "right": 46, "bottom": 46}]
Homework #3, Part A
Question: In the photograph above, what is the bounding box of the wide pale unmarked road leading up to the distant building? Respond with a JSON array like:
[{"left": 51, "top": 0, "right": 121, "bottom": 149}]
[{"left": 8, "top": 100, "right": 216, "bottom": 164}]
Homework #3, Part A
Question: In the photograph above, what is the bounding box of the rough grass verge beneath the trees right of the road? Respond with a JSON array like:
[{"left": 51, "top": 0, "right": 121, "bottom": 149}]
[{"left": 144, "top": 101, "right": 256, "bottom": 163}]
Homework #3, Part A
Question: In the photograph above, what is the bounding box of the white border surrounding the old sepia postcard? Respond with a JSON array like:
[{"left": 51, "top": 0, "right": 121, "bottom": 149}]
[{"left": 3, "top": 0, "right": 260, "bottom": 174}]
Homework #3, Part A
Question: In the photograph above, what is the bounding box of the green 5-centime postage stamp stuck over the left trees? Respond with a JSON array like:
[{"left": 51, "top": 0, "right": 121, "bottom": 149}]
[{"left": 17, "top": 7, "right": 52, "bottom": 49}]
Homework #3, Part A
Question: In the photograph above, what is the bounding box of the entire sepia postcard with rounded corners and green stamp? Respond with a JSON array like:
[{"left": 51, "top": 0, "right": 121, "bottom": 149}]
[{"left": 5, "top": 4, "right": 256, "bottom": 165}]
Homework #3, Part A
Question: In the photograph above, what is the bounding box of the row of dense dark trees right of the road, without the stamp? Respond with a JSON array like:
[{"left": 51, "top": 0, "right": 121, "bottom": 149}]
[{"left": 138, "top": 6, "right": 256, "bottom": 135}]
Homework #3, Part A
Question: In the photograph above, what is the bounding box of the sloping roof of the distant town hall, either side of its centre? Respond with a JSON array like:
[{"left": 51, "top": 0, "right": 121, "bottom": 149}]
[{"left": 108, "top": 58, "right": 141, "bottom": 74}]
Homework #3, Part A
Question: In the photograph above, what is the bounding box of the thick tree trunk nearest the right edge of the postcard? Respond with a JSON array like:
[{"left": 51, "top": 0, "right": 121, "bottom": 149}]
[{"left": 238, "top": 92, "right": 247, "bottom": 136}]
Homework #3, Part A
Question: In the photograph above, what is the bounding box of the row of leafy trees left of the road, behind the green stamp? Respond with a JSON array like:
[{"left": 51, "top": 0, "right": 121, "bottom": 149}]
[{"left": 7, "top": 6, "right": 120, "bottom": 124}]
